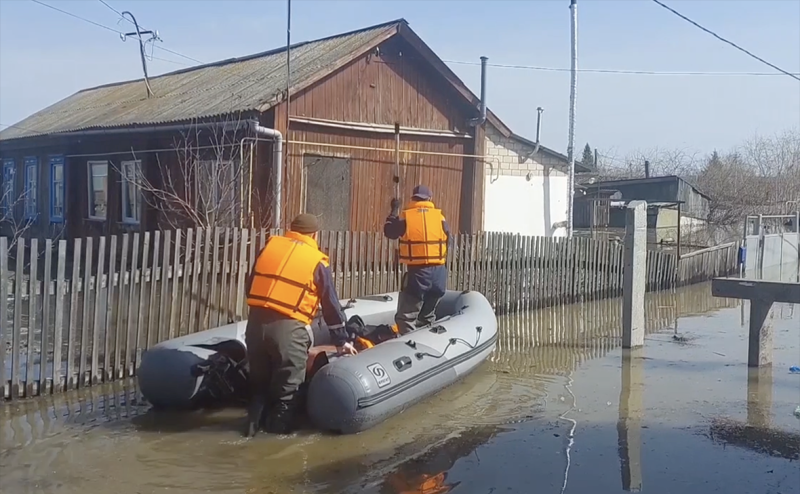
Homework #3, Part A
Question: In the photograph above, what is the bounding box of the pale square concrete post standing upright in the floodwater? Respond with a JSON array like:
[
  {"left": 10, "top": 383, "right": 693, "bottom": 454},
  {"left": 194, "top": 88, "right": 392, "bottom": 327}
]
[{"left": 622, "top": 201, "right": 647, "bottom": 348}]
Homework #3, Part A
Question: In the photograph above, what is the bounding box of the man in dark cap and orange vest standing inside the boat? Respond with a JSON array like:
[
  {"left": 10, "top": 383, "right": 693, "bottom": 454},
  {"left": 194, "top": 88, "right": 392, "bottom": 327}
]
[{"left": 383, "top": 185, "right": 450, "bottom": 334}]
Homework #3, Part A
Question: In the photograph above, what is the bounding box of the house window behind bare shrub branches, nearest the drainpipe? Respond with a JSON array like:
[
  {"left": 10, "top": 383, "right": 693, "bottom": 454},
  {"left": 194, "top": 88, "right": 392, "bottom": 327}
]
[{"left": 195, "top": 159, "right": 240, "bottom": 226}]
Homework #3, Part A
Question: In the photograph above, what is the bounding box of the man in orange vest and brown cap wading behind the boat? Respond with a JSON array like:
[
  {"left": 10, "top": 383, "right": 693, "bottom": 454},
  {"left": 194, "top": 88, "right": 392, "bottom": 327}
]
[{"left": 245, "top": 214, "right": 357, "bottom": 437}]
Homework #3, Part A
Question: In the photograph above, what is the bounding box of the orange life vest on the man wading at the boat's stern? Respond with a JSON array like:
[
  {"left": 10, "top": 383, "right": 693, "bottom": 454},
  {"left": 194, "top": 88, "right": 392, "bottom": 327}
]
[{"left": 247, "top": 231, "right": 328, "bottom": 324}]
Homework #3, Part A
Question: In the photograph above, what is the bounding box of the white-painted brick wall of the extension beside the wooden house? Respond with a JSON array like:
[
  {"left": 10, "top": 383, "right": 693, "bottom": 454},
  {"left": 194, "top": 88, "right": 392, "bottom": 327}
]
[{"left": 483, "top": 122, "right": 569, "bottom": 237}]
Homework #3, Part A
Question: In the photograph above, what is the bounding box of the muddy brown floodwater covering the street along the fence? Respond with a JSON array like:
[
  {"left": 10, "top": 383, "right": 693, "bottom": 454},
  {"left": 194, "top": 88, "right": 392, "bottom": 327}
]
[{"left": 0, "top": 284, "right": 800, "bottom": 494}]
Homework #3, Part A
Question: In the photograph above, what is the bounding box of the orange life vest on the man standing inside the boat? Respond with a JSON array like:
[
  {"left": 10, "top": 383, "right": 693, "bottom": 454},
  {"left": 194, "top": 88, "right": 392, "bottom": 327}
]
[{"left": 398, "top": 201, "right": 447, "bottom": 266}]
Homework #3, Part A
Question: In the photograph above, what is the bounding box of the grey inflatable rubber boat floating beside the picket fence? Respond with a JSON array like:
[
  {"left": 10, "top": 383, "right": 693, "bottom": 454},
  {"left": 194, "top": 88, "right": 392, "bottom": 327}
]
[{"left": 137, "top": 291, "right": 497, "bottom": 434}]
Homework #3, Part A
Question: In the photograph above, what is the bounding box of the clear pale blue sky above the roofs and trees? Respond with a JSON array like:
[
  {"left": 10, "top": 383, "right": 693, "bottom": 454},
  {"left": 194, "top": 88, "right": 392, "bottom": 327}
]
[{"left": 0, "top": 0, "right": 800, "bottom": 156}]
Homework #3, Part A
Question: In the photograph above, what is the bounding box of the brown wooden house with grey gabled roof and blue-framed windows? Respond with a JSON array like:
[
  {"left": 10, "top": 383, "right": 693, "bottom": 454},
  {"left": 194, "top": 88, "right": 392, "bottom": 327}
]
[{"left": 0, "top": 19, "right": 511, "bottom": 242}]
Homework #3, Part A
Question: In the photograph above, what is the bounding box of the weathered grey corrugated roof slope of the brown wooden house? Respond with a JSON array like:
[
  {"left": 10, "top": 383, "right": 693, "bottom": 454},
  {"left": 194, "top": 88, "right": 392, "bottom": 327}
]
[{"left": 0, "top": 19, "right": 400, "bottom": 140}]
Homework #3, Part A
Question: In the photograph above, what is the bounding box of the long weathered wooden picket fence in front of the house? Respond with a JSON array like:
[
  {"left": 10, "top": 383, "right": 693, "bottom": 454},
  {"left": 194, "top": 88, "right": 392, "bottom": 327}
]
[{"left": 0, "top": 228, "right": 738, "bottom": 399}]
